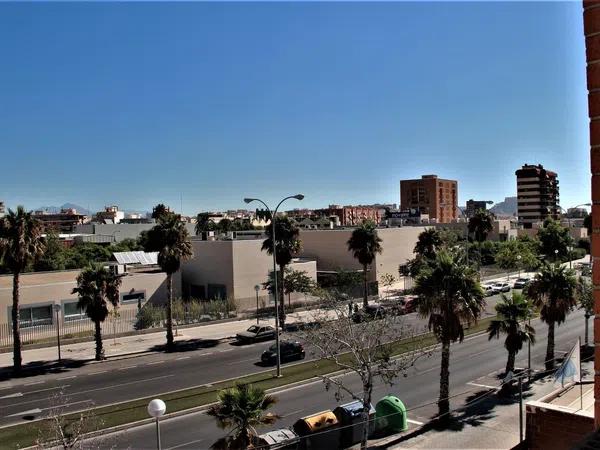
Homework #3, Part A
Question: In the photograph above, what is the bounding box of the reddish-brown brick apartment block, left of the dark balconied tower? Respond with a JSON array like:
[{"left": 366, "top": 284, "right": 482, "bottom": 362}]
[{"left": 400, "top": 175, "right": 458, "bottom": 223}]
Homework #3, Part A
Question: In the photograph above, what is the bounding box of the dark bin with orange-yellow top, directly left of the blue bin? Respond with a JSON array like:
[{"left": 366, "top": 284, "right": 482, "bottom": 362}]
[{"left": 293, "top": 410, "right": 340, "bottom": 450}]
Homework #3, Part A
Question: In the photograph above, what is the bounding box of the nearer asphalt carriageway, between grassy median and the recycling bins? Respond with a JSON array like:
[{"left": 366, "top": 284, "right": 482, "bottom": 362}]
[{"left": 102, "top": 311, "right": 589, "bottom": 450}]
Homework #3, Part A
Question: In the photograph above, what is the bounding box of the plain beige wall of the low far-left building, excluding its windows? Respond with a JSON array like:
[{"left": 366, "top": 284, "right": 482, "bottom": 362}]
[{"left": 0, "top": 270, "right": 181, "bottom": 323}]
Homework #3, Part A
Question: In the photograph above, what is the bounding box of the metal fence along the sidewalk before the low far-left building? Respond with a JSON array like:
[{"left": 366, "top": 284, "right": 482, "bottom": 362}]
[{"left": 0, "top": 309, "right": 137, "bottom": 347}]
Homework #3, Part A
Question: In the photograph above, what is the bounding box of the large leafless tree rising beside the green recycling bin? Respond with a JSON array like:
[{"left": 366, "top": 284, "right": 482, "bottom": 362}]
[{"left": 303, "top": 291, "right": 424, "bottom": 449}]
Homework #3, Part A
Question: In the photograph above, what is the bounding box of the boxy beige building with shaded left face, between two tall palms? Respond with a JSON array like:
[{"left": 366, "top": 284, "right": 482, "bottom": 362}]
[{"left": 182, "top": 237, "right": 317, "bottom": 310}]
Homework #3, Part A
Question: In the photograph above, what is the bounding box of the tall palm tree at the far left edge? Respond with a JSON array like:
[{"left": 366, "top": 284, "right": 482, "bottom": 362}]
[{"left": 0, "top": 206, "right": 46, "bottom": 373}]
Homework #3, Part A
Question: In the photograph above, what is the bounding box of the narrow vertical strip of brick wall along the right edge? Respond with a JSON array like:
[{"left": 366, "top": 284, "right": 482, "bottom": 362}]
[{"left": 583, "top": 0, "right": 600, "bottom": 428}]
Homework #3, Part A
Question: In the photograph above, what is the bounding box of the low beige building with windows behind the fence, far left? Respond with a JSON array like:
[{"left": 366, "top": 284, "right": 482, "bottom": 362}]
[{"left": 0, "top": 268, "right": 181, "bottom": 328}]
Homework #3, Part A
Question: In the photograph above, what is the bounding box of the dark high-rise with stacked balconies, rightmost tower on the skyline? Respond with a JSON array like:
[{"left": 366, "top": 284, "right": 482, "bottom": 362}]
[{"left": 515, "top": 164, "right": 559, "bottom": 228}]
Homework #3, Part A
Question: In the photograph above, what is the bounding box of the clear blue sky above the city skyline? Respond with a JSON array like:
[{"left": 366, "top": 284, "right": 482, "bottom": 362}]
[{"left": 0, "top": 2, "right": 590, "bottom": 214}]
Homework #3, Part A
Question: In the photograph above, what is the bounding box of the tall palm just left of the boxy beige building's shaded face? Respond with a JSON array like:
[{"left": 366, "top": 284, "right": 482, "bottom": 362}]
[{"left": 144, "top": 213, "right": 193, "bottom": 352}]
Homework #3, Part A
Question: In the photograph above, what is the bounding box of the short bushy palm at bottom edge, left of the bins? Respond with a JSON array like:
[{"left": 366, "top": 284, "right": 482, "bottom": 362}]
[{"left": 207, "top": 384, "right": 279, "bottom": 450}]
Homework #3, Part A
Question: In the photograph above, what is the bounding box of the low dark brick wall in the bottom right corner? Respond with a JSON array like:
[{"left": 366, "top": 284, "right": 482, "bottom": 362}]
[{"left": 525, "top": 402, "right": 594, "bottom": 450}]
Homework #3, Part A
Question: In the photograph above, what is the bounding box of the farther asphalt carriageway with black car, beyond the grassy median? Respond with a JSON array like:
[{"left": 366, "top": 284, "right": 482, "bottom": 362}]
[{"left": 0, "top": 296, "right": 506, "bottom": 426}]
